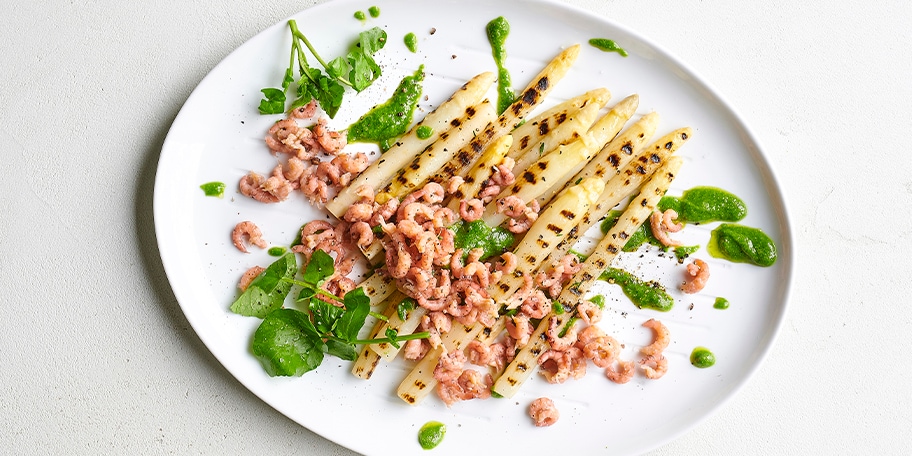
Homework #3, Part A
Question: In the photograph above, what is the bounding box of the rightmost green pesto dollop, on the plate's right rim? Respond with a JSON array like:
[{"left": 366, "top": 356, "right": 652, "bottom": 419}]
[{"left": 706, "top": 223, "right": 777, "bottom": 267}]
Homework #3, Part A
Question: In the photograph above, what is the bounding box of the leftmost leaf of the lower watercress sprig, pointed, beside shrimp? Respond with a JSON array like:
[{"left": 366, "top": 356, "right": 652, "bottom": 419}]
[{"left": 231, "top": 253, "right": 298, "bottom": 318}]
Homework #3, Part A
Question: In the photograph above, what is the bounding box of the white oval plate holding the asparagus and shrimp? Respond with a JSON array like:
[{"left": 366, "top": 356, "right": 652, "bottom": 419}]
[{"left": 154, "top": 0, "right": 794, "bottom": 454}]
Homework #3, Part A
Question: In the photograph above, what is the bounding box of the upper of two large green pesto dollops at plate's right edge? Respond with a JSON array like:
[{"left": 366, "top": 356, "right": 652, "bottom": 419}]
[{"left": 658, "top": 186, "right": 747, "bottom": 223}]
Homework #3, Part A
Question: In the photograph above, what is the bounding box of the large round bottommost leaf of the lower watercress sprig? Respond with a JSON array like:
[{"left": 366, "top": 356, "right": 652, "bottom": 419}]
[{"left": 251, "top": 309, "right": 324, "bottom": 377}]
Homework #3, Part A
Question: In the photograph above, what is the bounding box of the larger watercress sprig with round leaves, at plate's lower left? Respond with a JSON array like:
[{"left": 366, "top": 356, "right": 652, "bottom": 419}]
[{"left": 231, "top": 250, "right": 428, "bottom": 376}]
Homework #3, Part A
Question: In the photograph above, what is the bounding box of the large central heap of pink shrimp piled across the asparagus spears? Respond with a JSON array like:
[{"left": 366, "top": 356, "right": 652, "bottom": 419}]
[{"left": 340, "top": 178, "right": 550, "bottom": 374}]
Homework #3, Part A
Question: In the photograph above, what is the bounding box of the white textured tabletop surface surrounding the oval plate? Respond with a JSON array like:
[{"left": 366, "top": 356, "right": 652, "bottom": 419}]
[{"left": 0, "top": 0, "right": 912, "bottom": 455}]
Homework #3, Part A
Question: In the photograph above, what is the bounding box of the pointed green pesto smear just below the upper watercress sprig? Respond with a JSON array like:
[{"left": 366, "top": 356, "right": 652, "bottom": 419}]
[{"left": 348, "top": 65, "right": 424, "bottom": 150}]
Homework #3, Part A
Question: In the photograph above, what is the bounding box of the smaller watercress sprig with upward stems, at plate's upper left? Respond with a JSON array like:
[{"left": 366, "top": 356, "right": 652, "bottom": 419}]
[{"left": 259, "top": 19, "right": 386, "bottom": 117}]
